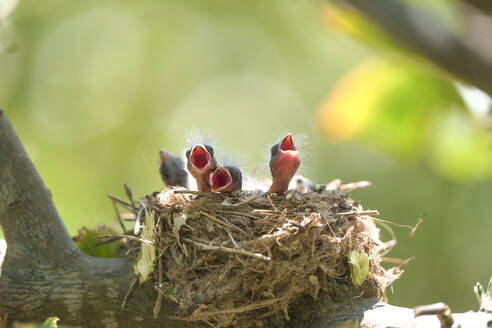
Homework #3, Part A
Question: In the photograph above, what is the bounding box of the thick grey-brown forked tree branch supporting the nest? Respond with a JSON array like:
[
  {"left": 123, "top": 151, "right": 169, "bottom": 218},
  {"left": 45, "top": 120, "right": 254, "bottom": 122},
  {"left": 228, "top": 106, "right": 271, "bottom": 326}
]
[{"left": 0, "top": 110, "right": 492, "bottom": 328}]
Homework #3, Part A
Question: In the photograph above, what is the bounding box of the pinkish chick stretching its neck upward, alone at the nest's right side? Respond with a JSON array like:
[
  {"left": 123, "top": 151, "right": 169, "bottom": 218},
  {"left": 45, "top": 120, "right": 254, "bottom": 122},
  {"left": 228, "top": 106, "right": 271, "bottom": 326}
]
[{"left": 268, "top": 133, "right": 301, "bottom": 195}]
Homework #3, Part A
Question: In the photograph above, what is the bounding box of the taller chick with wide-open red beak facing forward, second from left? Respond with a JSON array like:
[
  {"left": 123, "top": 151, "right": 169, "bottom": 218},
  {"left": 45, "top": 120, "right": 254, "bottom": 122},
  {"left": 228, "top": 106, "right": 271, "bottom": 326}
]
[{"left": 186, "top": 144, "right": 217, "bottom": 191}]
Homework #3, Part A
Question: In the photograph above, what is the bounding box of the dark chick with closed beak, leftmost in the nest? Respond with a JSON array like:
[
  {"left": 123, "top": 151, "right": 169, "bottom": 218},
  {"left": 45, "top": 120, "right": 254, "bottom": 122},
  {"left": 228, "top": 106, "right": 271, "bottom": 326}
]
[{"left": 159, "top": 149, "right": 188, "bottom": 188}]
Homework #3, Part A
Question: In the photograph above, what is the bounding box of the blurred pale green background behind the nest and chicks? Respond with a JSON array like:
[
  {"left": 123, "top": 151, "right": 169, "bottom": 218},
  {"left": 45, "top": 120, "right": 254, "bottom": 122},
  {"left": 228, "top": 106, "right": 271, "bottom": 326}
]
[{"left": 0, "top": 0, "right": 492, "bottom": 311}]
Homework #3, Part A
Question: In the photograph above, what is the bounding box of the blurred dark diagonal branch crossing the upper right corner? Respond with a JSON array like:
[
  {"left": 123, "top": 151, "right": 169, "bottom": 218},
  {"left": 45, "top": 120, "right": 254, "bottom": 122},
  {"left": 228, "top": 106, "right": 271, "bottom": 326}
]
[{"left": 338, "top": 0, "right": 492, "bottom": 95}]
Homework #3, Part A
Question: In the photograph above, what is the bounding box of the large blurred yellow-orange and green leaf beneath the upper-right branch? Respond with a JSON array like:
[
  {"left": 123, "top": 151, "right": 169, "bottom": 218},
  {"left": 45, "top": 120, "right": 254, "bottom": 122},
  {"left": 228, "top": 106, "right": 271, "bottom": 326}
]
[{"left": 318, "top": 59, "right": 463, "bottom": 160}]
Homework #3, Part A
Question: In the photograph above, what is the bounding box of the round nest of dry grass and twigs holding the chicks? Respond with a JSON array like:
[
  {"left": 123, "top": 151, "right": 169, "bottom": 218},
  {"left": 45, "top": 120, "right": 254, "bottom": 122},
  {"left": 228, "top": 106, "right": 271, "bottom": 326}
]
[{"left": 125, "top": 184, "right": 402, "bottom": 327}]
